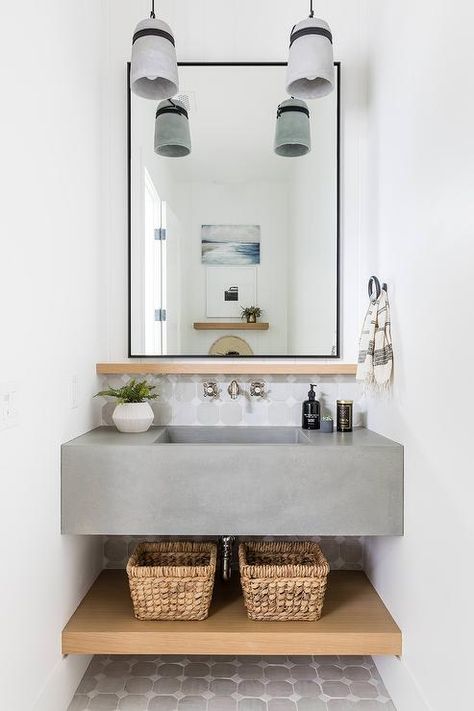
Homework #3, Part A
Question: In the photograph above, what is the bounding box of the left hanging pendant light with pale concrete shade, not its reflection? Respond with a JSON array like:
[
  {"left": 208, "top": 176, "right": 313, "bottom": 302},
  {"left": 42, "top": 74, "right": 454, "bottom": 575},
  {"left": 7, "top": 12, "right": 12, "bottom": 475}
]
[{"left": 130, "top": 0, "right": 179, "bottom": 99}]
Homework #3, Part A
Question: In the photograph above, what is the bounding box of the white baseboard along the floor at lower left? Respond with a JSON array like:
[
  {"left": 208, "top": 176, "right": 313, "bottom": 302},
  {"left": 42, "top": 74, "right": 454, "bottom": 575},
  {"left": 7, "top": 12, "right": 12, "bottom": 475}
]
[{"left": 32, "top": 655, "right": 92, "bottom": 711}]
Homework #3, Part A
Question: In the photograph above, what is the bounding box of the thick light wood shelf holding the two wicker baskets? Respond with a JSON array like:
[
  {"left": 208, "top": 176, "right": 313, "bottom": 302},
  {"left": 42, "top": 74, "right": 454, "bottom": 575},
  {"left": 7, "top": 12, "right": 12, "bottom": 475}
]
[{"left": 62, "top": 570, "right": 402, "bottom": 655}]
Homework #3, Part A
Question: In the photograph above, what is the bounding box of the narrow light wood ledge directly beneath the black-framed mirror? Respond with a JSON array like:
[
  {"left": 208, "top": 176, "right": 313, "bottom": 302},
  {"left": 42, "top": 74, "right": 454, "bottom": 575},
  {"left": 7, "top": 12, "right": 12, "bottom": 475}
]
[{"left": 96, "top": 364, "right": 357, "bottom": 375}]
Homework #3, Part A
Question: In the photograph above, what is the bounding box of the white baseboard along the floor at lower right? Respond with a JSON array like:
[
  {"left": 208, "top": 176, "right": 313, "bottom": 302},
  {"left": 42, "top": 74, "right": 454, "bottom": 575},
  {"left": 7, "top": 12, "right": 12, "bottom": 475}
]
[{"left": 374, "top": 657, "right": 432, "bottom": 711}]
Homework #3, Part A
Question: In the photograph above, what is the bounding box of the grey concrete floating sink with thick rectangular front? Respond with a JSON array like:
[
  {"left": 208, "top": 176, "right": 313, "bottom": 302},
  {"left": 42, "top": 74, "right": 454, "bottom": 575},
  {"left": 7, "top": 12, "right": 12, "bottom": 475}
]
[{"left": 62, "top": 427, "right": 403, "bottom": 536}]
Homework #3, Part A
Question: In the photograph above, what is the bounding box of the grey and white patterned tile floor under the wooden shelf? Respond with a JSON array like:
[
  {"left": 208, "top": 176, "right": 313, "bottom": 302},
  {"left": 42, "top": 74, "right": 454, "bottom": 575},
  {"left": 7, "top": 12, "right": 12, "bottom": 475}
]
[{"left": 68, "top": 656, "right": 396, "bottom": 711}]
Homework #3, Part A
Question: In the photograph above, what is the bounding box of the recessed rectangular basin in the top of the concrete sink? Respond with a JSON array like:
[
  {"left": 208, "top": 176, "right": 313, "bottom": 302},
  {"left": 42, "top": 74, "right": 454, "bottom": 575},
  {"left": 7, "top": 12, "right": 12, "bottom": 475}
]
[{"left": 155, "top": 426, "right": 310, "bottom": 444}]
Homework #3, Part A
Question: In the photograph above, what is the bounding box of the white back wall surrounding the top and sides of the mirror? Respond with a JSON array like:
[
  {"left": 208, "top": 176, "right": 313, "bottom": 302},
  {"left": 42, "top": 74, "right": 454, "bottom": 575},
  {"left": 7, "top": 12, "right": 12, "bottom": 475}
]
[{"left": 105, "top": 0, "right": 365, "bottom": 362}]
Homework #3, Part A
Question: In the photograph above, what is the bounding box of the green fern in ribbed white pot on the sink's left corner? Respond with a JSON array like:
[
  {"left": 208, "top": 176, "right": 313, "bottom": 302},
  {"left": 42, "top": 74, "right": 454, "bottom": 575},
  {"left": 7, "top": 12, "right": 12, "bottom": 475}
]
[{"left": 95, "top": 378, "right": 158, "bottom": 432}]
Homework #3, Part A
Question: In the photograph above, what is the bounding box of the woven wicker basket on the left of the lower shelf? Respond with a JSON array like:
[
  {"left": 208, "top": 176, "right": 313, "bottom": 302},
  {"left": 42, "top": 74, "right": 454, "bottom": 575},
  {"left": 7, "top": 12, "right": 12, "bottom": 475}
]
[{"left": 127, "top": 542, "right": 217, "bottom": 620}]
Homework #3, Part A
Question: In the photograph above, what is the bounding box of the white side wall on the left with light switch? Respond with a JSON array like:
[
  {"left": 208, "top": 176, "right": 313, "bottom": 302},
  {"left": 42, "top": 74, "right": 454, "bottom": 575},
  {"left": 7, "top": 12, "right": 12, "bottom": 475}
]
[{"left": 0, "top": 0, "right": 105, "bottom": 711}]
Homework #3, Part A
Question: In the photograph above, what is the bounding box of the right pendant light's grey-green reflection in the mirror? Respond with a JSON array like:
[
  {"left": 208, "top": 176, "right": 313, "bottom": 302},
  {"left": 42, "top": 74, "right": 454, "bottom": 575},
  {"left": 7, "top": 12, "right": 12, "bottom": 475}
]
[{"left": 275, "top": 97, "right": 311, "bottom": 158}]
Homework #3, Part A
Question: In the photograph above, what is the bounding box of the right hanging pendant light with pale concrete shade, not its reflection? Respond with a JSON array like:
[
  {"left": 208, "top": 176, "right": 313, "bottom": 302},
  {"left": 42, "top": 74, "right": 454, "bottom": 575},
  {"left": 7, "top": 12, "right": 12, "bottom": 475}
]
[{"left": 286, "top": 0, "right": 334, "bottom": 99}]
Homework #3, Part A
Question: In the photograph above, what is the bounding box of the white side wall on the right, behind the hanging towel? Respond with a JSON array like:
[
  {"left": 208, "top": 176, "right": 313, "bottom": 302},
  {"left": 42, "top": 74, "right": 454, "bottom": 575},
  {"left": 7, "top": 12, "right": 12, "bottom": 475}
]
[{"left": 363, "top": 0, "right": 474, "bottom": 711}]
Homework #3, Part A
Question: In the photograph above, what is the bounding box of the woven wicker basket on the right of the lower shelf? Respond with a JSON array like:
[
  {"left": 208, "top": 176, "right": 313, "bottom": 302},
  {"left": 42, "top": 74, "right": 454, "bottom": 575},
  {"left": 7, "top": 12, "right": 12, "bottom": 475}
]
[{"left": 239, "top": 541, "right": 329, "bottom": 621}]
